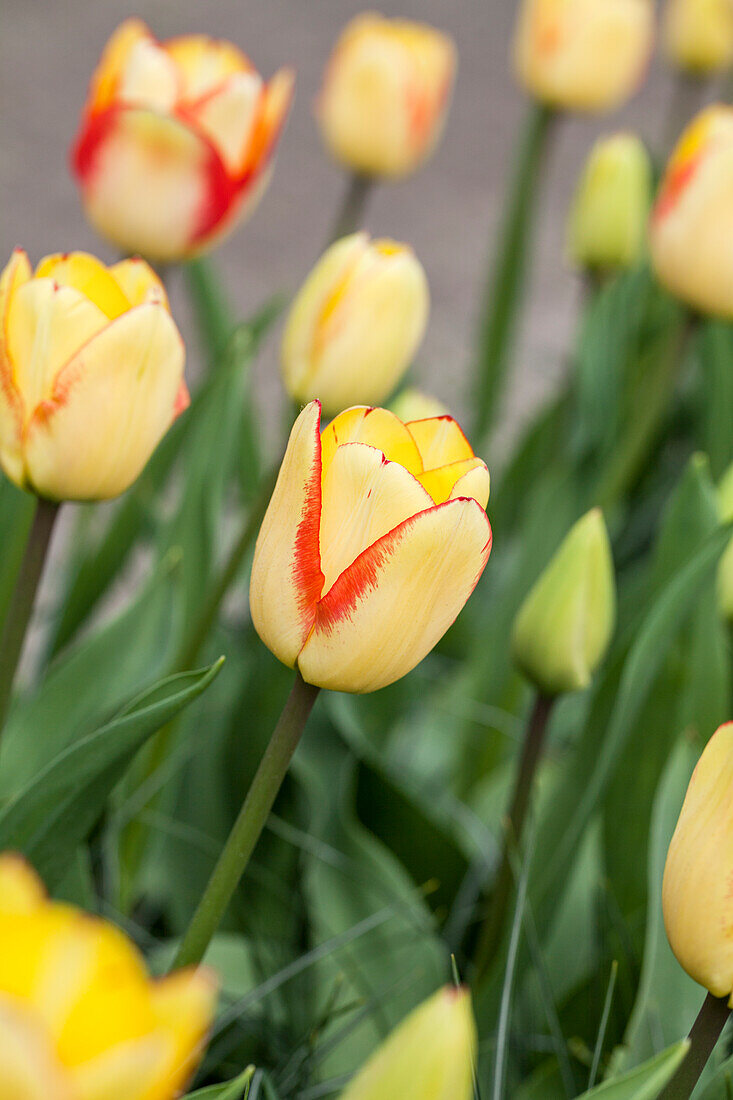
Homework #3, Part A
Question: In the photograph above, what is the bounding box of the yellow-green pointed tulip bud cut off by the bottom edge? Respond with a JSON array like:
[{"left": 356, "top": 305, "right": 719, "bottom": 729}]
[{"left": 340, "top": 987, "right": 477, "bottom": 1100}]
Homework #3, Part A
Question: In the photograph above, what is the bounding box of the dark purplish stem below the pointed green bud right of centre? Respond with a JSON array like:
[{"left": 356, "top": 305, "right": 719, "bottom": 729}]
[{"left": 474, "top": 692, "right": 555, "bottom": 982}]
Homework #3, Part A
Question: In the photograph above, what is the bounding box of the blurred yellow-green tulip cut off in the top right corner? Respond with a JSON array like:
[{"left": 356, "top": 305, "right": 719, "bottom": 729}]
[{"left": 664, "top": 0, "right": 733, "bottom": 76}]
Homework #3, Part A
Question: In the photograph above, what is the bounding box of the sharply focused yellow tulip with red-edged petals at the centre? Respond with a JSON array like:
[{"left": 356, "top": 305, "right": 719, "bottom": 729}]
[{"left": 250, "top": 402, "right": 491, "bottom": 692}]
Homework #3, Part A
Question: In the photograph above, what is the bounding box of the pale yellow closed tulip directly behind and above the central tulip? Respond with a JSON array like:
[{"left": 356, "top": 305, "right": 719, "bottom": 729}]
[{"left": 282, "top": 233, "right": 429, "bottom": 416}]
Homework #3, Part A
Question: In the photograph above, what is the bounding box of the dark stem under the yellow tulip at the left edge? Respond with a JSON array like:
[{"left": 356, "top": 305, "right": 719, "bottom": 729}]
[{"left": 0, "top": 498, "right": 58, "bottom": 730}]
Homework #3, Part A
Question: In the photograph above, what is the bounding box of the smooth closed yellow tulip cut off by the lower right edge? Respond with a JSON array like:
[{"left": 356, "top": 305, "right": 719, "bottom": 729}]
[{"left": 661, "top": 722, "right": 733, "bottom": 997}]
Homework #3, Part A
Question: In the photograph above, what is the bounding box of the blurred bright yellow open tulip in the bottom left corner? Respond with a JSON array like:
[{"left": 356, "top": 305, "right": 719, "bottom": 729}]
[{"left": 0, "top": 854, "right": 216, "bottom": 1100}]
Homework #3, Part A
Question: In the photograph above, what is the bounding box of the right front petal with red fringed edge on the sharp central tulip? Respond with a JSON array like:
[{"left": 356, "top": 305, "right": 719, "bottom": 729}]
[{"left": 298, "top": 501, "right": 491, "bottom": 692}]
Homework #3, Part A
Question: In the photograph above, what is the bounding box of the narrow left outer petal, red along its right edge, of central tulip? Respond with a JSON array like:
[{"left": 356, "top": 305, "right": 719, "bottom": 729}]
[{"left": 250, "top": 402, "right": 324, "bottom": 668}]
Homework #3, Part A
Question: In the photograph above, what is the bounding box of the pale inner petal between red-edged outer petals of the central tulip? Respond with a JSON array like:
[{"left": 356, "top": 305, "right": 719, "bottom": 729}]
[{"left": 320, "top": 443, "right": 433, "bottom": 593}]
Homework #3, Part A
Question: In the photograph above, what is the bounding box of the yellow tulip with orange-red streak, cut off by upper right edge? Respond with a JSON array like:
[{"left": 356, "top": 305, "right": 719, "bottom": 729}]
[{"left": 649, "top": 105, "right": 733, "bottom": 320}]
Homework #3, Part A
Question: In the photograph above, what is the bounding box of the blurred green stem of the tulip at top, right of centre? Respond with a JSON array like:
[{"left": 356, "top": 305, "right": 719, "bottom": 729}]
[{"left": 473, "top": 103, "right": 555, "bottom": 442}]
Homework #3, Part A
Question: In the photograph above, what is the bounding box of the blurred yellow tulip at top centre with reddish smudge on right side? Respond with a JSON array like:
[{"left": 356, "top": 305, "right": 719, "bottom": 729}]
[{"left": 318, "top": 13, "right": 456, "bottom": 177}]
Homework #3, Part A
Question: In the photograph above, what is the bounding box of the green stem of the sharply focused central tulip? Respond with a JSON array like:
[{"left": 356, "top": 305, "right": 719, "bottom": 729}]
[{"left": 173, "top": 671, "right": 319, "bottom": 969}]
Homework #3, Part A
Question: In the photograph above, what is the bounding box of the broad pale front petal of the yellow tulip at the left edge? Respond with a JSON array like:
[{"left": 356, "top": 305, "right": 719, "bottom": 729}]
[{"left": 26, "top": 301, "right": 185, "bottom": 499}]
